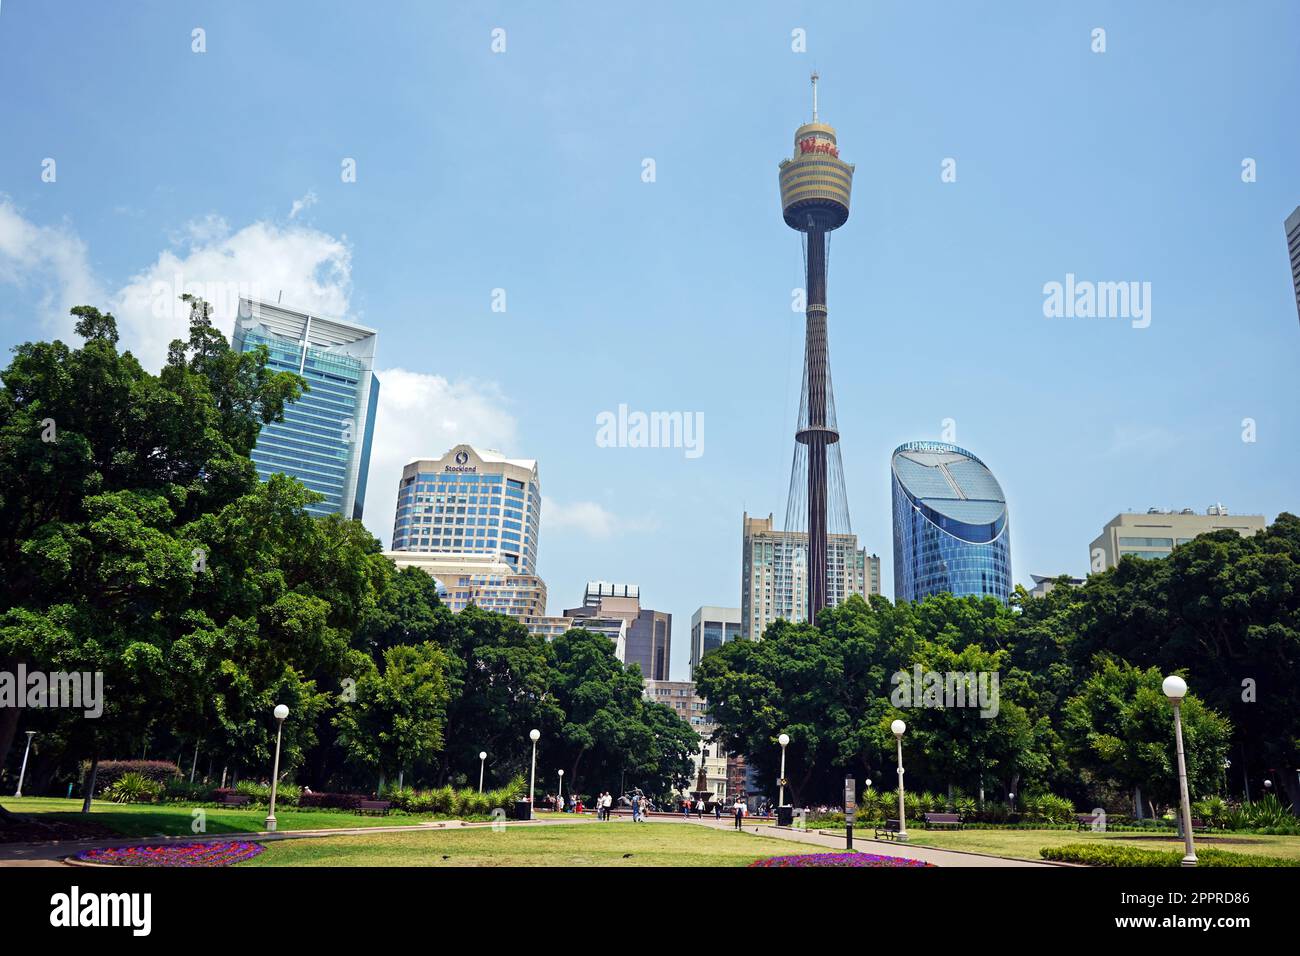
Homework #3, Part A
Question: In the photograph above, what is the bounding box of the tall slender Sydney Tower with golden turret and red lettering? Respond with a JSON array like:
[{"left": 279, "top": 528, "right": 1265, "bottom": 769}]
[{"left": 780, "top": 73, "right": 853, "bottom": 623}]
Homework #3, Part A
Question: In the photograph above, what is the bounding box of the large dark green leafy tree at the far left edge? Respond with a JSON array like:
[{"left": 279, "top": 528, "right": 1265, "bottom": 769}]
[{"left": 0, "top": 306, "right": 299, "bottom": 805}]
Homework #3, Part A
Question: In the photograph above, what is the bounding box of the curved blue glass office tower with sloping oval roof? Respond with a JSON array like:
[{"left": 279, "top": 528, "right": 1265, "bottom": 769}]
[{"left": 889, "top": 441, "right": 1011, "bottom": 602}]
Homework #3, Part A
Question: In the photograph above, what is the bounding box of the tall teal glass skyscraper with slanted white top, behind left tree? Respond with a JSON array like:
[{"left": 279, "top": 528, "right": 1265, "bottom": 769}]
[{"left": 231, "top": 299, "right": 380, "bottom": 520}]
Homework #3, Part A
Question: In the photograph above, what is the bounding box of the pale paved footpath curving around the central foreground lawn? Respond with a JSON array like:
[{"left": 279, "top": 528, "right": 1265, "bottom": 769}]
[{"left": 0, "top": 813, "right": 1054, "bottom": 866}]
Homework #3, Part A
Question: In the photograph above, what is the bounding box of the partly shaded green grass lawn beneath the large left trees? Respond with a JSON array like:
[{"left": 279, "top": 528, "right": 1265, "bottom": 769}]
[{"left": 0, "top": 797, "right": 434, "bottom": 836}]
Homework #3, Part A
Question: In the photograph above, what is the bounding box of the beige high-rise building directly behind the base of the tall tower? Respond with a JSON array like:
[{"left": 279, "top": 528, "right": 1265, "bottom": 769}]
[{"left": 740, "top": 514, "right": 880, "bottom": 639}]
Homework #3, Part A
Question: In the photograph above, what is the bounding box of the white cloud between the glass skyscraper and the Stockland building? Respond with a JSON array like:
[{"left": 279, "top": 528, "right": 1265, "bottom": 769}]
[{"left": 365, "top": 366, "right": 517, "bottom": 546}]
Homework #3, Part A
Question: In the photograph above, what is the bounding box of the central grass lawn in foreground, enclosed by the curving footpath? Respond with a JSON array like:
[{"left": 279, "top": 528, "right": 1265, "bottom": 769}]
[{"left": 239, "top": 821, "right": 824, "bottom": 866}]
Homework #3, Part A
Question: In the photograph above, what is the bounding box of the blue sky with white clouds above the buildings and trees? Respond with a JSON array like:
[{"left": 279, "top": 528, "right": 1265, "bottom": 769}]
[{"left": 0, "top": 0, "right": 1300, "bottom": 679}]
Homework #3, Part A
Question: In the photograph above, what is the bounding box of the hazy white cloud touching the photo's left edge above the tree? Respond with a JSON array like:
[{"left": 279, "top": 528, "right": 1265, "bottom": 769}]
[{"left": 0, "top": 196, "right": 104, "bottom": 339}]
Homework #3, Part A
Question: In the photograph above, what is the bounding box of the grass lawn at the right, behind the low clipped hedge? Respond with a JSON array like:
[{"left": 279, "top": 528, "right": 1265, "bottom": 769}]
[{"left": 889, "top": 827, "right": 1300, "bottom": 860}]
